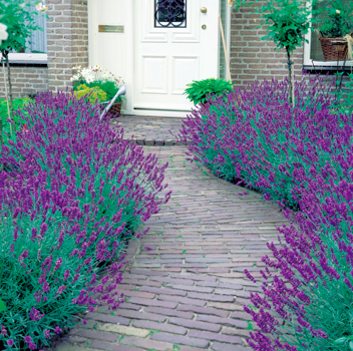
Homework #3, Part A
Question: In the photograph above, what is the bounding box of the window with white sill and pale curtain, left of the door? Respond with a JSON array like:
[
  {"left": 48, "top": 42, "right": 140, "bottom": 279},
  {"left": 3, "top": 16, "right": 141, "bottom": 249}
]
[{"left": 9, "top": 6, "right": 47, "bottom": 63}]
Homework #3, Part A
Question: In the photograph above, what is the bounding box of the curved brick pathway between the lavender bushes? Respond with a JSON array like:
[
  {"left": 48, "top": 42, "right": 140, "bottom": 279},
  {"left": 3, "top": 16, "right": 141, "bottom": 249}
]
[{"left": 55, "top": 117, "right": 284, "bottom": 351}]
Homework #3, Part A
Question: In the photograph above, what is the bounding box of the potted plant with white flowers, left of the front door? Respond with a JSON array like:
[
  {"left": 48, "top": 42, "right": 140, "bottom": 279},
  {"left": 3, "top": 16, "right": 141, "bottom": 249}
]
[{"left": 71, "top": 66, "right": 125, "bottom": 116}]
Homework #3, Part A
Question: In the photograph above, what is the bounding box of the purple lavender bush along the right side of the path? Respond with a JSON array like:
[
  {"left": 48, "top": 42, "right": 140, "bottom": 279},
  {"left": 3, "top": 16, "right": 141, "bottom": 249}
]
[{"left": 180, "top": 78, "right": 353, "bottom": 351}]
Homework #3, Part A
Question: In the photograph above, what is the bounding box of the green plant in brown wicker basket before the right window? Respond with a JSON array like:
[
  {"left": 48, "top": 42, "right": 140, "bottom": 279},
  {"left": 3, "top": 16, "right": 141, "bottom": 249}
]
[{"left": 319, "top": 0, "right": 353, "bottom": 61}]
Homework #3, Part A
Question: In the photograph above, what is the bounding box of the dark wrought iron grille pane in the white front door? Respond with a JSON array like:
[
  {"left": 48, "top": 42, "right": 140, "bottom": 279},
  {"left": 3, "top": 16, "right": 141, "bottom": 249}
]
[{"left": 154, "top": 0, "right": 187, "bottom": 28}]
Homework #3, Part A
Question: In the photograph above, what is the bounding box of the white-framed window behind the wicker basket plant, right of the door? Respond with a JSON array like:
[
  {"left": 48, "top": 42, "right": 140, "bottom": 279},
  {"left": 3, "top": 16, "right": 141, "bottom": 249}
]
[{"left": 304, "top": 0, "right": 353, "bottom": 67}]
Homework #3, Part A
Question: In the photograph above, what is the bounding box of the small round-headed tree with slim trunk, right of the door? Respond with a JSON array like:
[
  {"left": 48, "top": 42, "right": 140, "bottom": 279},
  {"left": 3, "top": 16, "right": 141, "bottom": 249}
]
[{"left": 230, "top": 0, "right": 317, "bottom": 103}]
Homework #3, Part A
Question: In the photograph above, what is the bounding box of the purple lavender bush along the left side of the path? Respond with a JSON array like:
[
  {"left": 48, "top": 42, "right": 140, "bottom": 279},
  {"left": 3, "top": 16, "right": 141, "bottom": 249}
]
[{"left": 0, "top": 93, "right": 170, "bottom": 350}]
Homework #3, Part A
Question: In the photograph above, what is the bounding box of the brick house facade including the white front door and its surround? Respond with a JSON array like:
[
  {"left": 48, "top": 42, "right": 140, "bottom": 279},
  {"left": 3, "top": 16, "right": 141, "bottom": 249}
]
[{"left": 0, "top": 0, "right": 352, "bottom": 117}]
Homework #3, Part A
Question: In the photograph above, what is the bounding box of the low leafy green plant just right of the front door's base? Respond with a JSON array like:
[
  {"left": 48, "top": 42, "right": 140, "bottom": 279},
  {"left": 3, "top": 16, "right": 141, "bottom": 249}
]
[{"left": 184, "top": 78, "right": 233, "bottom": 105}]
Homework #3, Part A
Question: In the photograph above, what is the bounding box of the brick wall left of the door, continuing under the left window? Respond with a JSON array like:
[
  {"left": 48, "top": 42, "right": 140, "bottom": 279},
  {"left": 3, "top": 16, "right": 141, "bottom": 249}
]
[{"left": 0, "top": 0, "right": 88, "bottom": 98}]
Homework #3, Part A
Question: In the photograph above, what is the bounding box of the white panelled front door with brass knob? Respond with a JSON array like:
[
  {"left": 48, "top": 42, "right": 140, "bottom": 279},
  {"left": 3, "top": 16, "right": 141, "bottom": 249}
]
[{"left": 132, "top": 0, "right": 219, "bottom": 115}]
